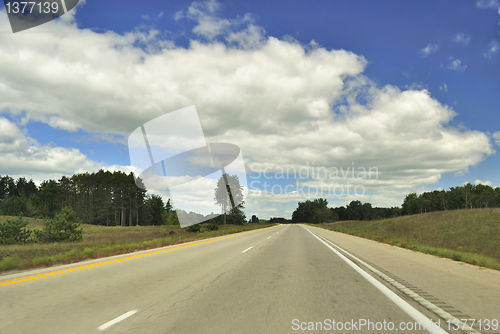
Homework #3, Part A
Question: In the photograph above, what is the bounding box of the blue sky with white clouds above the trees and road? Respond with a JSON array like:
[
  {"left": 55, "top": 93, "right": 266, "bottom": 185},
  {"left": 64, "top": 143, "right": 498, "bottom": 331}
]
[{"left": 0, "top": 0, "right": 500, "bottom": 218}]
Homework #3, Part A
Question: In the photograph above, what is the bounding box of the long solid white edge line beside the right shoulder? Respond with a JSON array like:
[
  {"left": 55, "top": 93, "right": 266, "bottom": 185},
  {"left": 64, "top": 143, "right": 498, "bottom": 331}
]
[{"left": 302, "top": 226, "right": 448, "bottom": 334}]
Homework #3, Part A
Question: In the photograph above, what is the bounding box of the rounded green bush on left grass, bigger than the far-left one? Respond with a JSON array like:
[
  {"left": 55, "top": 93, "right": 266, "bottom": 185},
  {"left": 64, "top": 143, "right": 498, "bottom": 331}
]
[{"left": 35, "top": 207, "right": 83, "bottom": 242}]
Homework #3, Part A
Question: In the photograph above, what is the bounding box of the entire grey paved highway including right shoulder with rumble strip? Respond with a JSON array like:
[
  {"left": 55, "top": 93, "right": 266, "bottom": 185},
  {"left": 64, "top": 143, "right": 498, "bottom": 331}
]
[{"left": 0, "top": 225, "right": 500, "bottom": 334}]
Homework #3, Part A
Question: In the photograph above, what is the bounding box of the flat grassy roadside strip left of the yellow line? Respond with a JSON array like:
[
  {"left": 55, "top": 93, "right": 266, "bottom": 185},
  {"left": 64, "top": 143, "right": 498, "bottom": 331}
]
[{"left": 0, "top": 217, "right": 273, "bottom": 272}]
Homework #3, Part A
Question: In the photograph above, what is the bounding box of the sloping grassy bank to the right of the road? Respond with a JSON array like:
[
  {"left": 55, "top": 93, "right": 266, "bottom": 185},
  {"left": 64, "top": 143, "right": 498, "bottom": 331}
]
[{"left": 308, "top": 208, "right": 500, "bottom": 270}]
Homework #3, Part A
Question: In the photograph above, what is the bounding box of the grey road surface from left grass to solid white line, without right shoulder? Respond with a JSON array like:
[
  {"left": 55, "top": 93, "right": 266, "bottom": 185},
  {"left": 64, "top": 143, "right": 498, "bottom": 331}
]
[{"left": 0, "top": 225, "right": 500, "bottom": 334}]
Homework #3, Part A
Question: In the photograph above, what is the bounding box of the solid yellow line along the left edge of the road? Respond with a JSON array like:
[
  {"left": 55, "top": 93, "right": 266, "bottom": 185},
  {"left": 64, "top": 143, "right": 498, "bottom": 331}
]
[{"left": 0, "top": 226, "right": 274, "bottom": 286}]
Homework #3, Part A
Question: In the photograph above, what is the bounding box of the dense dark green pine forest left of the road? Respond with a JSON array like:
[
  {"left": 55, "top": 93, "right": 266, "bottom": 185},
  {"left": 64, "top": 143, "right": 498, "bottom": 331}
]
[{"left": 0, "top": 170, "right": 178, "bottom": 226}]
